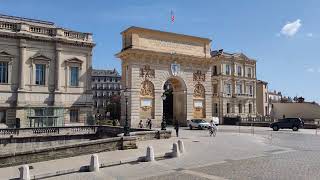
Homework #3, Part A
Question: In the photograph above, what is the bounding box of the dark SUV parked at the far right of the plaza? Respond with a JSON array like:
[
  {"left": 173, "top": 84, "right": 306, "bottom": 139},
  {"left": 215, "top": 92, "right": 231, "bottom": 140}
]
[{"left": 270, "top": 118, "right": 304, "bottom": 131}]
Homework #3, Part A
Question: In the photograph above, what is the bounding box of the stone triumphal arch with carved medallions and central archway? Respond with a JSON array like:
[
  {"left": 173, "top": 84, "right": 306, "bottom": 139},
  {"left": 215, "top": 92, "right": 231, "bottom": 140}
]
[{"left": 117, "top": 27, "right": 212, "bottom": 127}]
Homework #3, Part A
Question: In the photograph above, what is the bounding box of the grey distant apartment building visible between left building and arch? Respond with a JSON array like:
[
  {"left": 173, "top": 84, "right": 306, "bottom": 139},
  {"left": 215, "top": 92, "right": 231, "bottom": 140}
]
[{"left": 91, "top": 69, "right": 121, "bottom": 119}]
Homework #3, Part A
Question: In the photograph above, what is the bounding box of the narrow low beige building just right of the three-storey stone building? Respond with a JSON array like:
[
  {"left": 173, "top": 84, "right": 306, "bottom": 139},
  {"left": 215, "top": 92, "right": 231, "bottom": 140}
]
[{"left": 256, "top": 80, "right": 270, "bottom": 116}]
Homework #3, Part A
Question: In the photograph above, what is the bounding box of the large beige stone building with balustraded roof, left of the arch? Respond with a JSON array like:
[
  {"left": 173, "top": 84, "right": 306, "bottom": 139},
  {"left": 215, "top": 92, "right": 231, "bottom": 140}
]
[{"left": 0, "top": 15, "right": 94, "bottom": 127}]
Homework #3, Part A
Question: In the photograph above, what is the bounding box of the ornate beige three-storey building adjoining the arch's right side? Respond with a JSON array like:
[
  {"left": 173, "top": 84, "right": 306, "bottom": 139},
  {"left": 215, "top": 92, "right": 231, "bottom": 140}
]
[{"left": 211, "top": 50, "right": 256, "bottom": 120}]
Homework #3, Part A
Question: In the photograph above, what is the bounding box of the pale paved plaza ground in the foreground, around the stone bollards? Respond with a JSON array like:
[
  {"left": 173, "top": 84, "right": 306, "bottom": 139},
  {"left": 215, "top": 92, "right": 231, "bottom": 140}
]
[{"left": 0, "top": 126, "right": 320, "bottom": 180}]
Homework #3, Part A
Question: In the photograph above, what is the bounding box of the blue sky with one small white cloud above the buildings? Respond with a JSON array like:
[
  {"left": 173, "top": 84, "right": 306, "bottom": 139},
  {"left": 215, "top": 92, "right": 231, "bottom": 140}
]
[{"left": 0, "top": 0, "right": 320, "bottom": 102}]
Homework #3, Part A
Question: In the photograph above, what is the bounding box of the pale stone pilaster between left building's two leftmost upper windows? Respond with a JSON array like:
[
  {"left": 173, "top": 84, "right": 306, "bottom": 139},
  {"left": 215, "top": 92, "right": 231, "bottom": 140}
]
[{"left": 19, "top": 39, "right": 27, "bottom": 90}]
